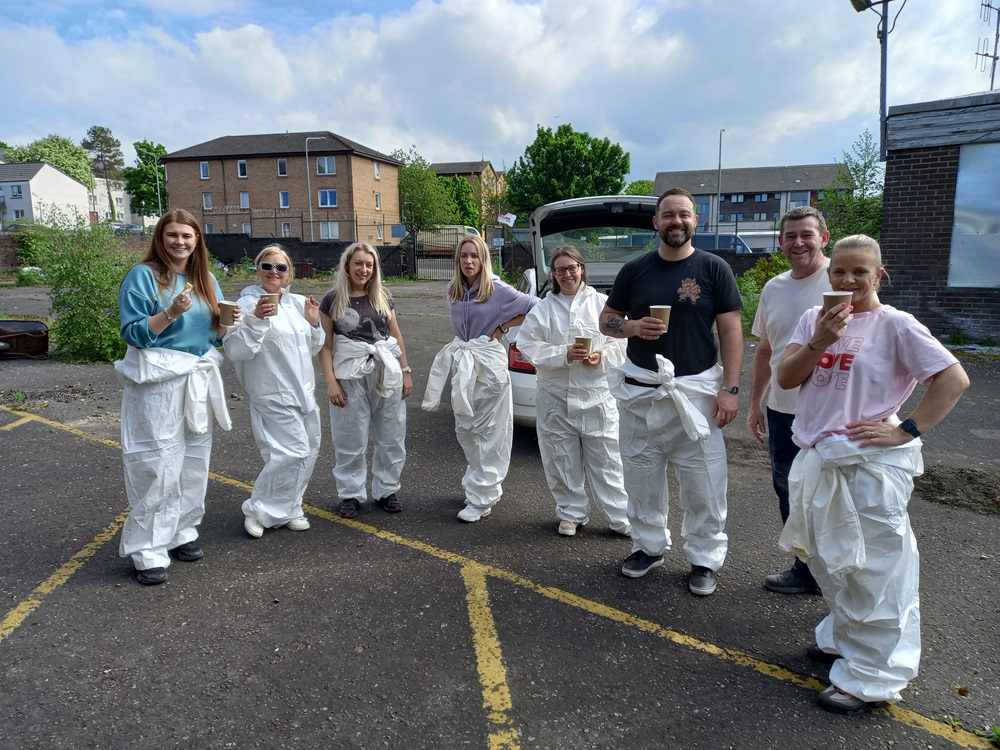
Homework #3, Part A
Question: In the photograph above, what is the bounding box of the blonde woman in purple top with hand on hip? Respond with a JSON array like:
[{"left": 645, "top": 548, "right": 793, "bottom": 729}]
[{"left": 422, "top": 236, "right": 538, "bottom": 523}]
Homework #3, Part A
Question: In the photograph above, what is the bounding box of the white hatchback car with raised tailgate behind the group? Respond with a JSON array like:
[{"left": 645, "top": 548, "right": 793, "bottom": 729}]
[{"left": 504, "top": 195, "right": 660, "bottom": 427}]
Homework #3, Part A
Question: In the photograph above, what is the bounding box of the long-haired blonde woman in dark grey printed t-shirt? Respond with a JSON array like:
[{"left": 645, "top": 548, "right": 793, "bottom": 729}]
[{"left": 319, "top": 242, "right": 413, "bottom": 518}]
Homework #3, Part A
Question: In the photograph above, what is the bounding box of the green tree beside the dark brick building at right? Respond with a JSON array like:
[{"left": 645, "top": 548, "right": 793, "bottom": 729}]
[{"left": 819, "top": 130, "right": 885, "bottom": 242}]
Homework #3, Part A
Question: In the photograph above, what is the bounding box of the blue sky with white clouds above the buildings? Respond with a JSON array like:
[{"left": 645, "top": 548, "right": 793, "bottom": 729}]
[{"left": 0, "top": 0, "right": 1000, "bottom": 179}]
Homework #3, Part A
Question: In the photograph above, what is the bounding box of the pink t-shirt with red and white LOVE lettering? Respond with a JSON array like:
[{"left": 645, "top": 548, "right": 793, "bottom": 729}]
[{"left": 788, "top": 305, "right": 958, "bottom": 447}]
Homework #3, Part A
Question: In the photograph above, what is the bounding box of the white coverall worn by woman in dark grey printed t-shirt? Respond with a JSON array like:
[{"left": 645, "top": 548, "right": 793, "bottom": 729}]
[{"left": 330, "top": 333, "right": 406, "bottom": 501}]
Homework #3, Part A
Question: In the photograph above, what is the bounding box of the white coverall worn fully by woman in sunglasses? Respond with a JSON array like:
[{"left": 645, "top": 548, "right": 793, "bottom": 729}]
[{"left": 223, "top": 286, "right": 326, "bottom": 528}]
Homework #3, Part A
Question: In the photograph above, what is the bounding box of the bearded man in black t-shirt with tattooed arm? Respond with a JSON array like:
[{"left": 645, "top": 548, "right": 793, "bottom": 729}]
[{"left": 601, "top": 188, "right": 743, "bottom": 596}]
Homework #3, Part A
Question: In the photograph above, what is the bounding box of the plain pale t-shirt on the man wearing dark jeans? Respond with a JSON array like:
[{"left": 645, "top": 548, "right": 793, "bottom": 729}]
[{"left": 752, "top": 259, "right": 830, "bottom": 414}]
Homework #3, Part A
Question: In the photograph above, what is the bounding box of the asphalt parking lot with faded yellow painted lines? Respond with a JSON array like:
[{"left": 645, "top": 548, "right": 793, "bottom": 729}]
[{"left": 0, "top": 282, "right": 1000, "bottom": 750}]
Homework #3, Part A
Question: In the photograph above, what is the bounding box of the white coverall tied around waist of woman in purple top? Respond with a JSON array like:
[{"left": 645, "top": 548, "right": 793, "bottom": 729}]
[{"left": 421, "top": 336, "right": 514, "bottom": 508}]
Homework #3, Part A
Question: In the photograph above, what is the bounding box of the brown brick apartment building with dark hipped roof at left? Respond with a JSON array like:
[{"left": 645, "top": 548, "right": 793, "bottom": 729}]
[{"left": 161, "top": 131, "right": 400, "bottom": 245}]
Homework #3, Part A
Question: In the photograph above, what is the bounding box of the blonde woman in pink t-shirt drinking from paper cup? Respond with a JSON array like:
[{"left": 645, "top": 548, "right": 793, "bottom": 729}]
[{"left": 778, "top": 235, "right": 969, "bottom": 714}]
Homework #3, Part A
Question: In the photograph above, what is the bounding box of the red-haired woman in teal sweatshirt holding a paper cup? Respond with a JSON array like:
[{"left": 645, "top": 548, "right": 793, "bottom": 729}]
[{"left": 115, "top": 209, "right": 238, "bottom": 586}]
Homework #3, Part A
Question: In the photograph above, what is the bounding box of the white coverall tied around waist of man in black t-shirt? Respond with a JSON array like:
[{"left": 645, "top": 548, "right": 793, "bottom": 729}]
[{"left": 608, "top": 354, "right": 729, "bottom": 570}]
